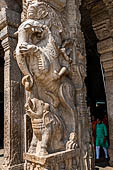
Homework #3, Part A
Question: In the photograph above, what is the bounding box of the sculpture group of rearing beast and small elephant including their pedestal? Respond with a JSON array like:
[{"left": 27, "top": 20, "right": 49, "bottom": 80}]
[{"left": 16, "top": 0, "right": 93, "bottom": 170}]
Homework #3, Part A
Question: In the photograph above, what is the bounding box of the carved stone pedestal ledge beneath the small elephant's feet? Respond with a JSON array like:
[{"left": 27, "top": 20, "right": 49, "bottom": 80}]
[{"left": 24, "top": 149, "right": 80, "bottom": 170}]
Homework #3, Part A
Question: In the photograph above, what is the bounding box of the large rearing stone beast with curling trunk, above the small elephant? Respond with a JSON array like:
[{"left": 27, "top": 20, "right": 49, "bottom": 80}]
[{"left": 16, "top": 1, "right": 77, "bottom": 146}]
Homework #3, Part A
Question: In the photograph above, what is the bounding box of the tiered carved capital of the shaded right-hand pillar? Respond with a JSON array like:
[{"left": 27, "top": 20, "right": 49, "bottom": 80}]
[{"left": 93, "top": 19, "right": 113, "bottom": 78}]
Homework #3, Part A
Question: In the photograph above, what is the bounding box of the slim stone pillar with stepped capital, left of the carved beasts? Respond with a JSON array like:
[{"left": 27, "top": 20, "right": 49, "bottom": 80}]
[{"left": 0, "top": 8, "right": 24, "bottom": 170}]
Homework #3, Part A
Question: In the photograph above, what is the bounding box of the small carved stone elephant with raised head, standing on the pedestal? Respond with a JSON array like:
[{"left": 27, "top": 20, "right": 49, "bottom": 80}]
[{"left": 25, "top": 98, "right": 64, "bottom": 156}]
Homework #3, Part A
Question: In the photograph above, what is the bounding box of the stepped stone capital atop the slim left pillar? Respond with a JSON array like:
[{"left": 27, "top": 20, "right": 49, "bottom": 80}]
[{"left": 0, "top": 8, "right": 20, "bottom": 51}]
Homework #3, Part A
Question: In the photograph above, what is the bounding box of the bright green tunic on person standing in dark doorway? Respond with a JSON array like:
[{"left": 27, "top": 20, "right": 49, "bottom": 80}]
[{"left": 96, "top": 123, "right": 108, "bottom": 148}]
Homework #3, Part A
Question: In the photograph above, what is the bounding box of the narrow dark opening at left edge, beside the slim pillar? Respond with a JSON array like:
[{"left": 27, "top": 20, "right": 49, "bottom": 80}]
[{"left": 0, "top": 41, "right": 4, "bottom": 149}]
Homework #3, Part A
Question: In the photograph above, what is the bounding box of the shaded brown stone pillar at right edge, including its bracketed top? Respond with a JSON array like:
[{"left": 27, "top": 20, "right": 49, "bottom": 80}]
[{"left": 92, "top": 0, "right": 113, "bottom": 165}]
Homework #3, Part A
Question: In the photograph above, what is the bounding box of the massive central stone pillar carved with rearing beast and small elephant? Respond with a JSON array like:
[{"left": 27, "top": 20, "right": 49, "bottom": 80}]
[{"left": 15, "top": 0, "right": 94, "bottom": 170}]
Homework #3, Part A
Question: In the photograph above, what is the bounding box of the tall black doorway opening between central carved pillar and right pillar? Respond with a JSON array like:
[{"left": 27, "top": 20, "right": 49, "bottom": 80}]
[{"left": 80, "top": 2, "right": 109, "bottom": 165}]
